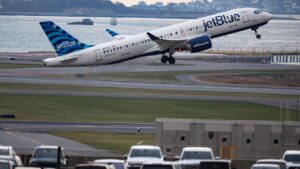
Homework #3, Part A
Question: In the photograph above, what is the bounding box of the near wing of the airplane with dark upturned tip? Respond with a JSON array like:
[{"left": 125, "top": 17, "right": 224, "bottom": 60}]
[{"left": 147, "top": 32, "right": 189, "bottom": 52}]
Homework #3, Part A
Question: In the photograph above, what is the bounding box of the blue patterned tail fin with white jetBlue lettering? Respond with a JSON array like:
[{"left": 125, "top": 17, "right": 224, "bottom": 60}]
[{"left": 40, "top": 21, "right": 92, "bottom": 56}]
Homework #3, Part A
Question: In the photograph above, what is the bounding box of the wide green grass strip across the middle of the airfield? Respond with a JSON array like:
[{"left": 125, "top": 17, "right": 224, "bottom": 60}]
[{"left": 0, "top": 94, "right": 296, "bottom": 122}]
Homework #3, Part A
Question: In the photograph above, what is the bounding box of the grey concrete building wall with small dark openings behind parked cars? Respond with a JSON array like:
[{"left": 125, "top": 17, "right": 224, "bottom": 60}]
[{"left": 155, "top": 118, "right": 300, "bottom": 160}]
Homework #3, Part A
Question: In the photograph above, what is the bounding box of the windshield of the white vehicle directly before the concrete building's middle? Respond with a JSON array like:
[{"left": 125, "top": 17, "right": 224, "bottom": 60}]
[{"left": 182, "top": 151, "right": 213, "bottom": 160}]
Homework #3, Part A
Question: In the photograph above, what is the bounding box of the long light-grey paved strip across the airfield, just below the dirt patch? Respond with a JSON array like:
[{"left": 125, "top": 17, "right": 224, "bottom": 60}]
[{"left": 0, "top": 77, "right": 300, "bottom": 95}]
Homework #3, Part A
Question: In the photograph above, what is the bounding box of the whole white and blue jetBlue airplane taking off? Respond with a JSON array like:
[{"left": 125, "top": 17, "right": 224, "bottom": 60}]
[{"left": 40, "top": 8, "right": 272, "bottom": 66}]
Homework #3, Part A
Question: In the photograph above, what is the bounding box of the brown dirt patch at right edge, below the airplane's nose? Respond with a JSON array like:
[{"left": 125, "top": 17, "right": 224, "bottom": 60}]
[{"left": 194, "top": 72, "right": 300, "bottom": 87}]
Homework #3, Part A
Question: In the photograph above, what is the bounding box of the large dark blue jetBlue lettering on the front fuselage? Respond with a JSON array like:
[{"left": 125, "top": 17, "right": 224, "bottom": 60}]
[{"left": 203, "top": 14, "right": 241, "bottom": 32}]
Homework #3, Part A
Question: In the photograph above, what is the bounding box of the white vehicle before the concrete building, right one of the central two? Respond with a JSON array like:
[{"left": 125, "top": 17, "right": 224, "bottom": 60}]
[{"left": 177, "top": 147, "right": 214, "bottom": 169}]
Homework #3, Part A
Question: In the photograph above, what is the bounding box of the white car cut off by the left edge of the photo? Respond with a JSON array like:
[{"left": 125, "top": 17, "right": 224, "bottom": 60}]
[{"left": 0, "top": 146, "right": 23, "bottom": 166}]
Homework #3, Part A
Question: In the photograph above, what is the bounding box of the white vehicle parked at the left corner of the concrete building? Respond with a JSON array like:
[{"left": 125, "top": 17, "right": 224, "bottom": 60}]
[{"left": 126, "top": 145, "right": 164, "bottom": 169}]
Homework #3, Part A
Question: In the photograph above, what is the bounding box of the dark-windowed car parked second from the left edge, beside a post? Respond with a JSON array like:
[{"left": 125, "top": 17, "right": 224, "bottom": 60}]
[{"left": 29, "top": 146, "right": 67, "bottom": 167}]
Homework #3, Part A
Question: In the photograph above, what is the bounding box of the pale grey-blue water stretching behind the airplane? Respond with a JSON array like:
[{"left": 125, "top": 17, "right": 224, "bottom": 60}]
[{"left": 0, "top": 16, "right": 300, "bottom": 52}]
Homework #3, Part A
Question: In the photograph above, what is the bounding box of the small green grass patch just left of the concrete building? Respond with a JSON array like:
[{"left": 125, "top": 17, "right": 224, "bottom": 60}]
[{"left": 50, "top": 132, "right": 154, "bottom": 154}]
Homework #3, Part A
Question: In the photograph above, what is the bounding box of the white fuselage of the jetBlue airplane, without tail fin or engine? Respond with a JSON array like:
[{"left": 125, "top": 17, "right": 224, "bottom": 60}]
[{"left": 44, "top": 8, "right": 271, "bottom": 66}]
